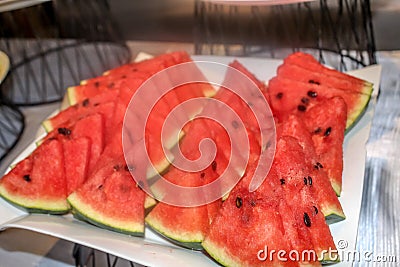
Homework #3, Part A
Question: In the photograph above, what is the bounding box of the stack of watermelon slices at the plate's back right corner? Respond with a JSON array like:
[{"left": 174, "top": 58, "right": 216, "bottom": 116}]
[{"left": 266, "top": 52, "right": 373, "bottom": 196}]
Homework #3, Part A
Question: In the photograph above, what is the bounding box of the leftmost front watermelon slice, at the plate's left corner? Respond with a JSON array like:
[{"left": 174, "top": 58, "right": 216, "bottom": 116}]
[{"left": 0, "top": 139, "right": 69, "bottom": 214}]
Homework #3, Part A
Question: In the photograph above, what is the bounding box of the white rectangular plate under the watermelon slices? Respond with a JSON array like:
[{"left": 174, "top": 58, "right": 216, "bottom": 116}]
[{"left": 0, "top": 56, "right": 381, "bottom": 266}]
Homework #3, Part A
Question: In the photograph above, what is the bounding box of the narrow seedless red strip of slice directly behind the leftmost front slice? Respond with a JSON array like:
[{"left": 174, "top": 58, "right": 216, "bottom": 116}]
[{"left": 63, "top": 137, "right": 91, "bottom": 195}]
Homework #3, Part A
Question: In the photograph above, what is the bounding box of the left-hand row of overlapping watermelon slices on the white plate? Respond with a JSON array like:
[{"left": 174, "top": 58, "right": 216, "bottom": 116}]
[{"left": 0, "top": 52, "right": 215, "bottom": 235}]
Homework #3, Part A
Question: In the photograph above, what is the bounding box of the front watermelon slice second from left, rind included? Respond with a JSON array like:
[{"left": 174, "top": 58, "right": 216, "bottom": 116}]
[{"left": 68, "top": 157, "right": 145, "bottom": 236}]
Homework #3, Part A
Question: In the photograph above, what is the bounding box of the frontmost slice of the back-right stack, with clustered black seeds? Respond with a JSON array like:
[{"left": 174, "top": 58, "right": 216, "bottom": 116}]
[{"left": 268, "top": 77, "right": 370, "bottom": 128}]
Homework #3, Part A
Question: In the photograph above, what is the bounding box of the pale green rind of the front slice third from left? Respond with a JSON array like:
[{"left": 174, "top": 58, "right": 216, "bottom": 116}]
[{"left": 145, "top": 216, "right": 203, "bottom": 250}]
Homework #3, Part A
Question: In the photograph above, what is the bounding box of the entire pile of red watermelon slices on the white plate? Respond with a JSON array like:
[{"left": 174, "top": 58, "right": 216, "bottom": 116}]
[{"left": 0, "top": 52, "right": 372, "bottom": 266}]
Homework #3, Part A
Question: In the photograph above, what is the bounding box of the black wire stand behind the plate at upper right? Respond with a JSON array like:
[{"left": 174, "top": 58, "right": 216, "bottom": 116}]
[{"left": 195, "top": 0, "right": 376, "bottom": 70}]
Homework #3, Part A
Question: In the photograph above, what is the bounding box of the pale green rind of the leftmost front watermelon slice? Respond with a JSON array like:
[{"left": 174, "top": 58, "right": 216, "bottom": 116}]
[{"left": 0, "top": 185, "right": 70, "bottom": 215}]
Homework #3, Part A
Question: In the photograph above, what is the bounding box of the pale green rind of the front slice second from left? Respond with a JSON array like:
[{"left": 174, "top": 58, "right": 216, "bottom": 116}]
[{"left": 67, "top": 192, "right": 144, "bottom": 237}]
